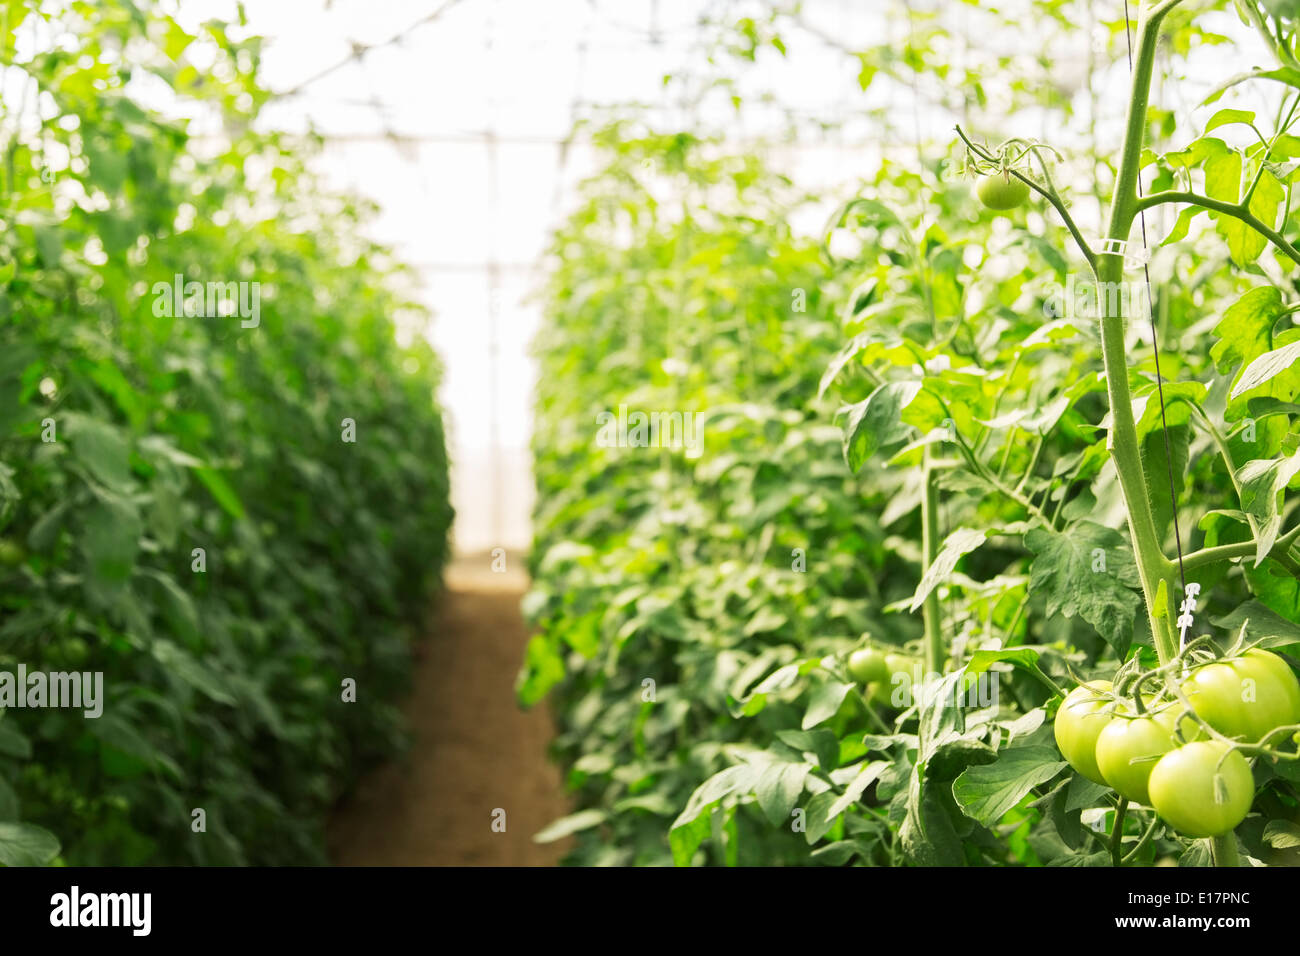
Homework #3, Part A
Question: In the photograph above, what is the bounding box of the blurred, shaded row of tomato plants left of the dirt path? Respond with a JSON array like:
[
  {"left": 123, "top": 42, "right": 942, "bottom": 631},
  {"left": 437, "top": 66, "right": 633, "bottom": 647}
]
[{"left": 0, "top": 0, "right": 451, "bottom": 865}]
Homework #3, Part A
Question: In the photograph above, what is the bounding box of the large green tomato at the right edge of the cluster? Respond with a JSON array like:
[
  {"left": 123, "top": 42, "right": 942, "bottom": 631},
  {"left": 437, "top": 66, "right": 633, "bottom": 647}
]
[{"left": 1183, "top": 649, "right": 1300, "bottom": 743}]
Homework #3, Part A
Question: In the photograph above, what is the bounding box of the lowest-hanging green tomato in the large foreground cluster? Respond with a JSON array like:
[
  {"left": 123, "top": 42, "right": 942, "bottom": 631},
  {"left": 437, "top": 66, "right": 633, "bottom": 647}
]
[{"left": 1148, "top": 740, "right": 1255, "bottom": 836}]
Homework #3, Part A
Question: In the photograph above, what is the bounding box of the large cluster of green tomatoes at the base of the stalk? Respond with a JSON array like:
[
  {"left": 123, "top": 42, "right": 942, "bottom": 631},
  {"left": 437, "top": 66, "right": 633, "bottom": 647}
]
[{"left": 1054, "top": 649, "right": 1300, "bottom": 838}]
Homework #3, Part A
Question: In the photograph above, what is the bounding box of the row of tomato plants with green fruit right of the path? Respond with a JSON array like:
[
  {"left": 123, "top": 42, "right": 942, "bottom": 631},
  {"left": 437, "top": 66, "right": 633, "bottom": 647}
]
[{"left": 520, "top": 3, "right": 1300, "bottom": 865}]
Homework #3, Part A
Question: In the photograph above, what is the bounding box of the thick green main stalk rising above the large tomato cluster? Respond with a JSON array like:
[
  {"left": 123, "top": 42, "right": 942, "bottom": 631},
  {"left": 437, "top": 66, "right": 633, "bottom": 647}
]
[{"left": 1097, "top": 0, "right": 1178, "bottom": 663}]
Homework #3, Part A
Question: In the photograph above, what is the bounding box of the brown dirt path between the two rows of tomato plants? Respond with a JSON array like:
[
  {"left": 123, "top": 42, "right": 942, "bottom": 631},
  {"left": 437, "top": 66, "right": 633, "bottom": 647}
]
[{"left": 329, "top": 555, "right": 568, "bottom": 866}]
